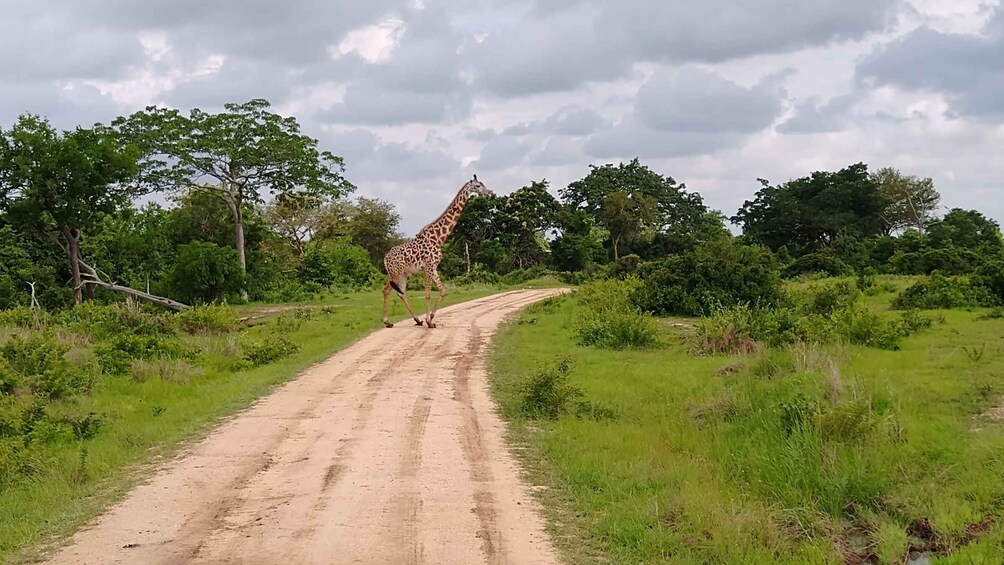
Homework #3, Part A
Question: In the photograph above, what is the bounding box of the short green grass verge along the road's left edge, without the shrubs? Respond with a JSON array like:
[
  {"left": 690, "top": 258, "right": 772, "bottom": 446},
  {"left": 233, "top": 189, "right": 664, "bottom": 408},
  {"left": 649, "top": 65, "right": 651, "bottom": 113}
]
[{"left": 0, "top": 282, "right": 549, "bottom": 562}]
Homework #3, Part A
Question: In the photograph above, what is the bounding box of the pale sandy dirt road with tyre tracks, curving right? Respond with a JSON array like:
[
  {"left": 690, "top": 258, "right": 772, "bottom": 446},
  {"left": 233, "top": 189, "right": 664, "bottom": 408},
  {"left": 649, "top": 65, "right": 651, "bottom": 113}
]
[{"left": 43, "top": 290, "right": 559, "bottom": 565}]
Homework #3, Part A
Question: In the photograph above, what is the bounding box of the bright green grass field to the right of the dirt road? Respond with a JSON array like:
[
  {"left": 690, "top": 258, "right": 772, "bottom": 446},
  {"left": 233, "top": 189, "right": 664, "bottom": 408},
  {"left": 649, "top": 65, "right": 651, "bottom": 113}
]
[{"left": 490, "top": 287, "right": 1004, "bottom": 564}]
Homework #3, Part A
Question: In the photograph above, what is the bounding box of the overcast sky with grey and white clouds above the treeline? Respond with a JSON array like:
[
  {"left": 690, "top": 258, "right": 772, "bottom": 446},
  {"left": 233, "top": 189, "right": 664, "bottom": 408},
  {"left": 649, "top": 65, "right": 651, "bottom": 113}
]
[{"left": 0, "top": 0, "right": 1004, "bottom": 235}]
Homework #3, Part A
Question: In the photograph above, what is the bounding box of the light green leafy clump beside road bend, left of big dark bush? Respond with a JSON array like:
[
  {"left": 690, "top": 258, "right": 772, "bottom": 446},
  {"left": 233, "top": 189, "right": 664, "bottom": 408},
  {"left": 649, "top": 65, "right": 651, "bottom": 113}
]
[{"left": 574, "top": 279, "right": 659, "bottom": 349}]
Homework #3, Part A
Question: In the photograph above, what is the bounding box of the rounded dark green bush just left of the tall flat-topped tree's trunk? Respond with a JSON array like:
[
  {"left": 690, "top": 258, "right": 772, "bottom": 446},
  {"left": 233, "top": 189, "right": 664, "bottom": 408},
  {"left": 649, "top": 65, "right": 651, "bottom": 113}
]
[{"left": 170, "top": 241, "right": 244, "bottom": 303}]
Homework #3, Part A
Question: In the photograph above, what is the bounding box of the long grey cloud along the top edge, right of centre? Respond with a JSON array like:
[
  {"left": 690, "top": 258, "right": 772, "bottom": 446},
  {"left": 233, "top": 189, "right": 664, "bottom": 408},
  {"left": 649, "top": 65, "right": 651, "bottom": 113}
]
[{"left": 470, "top": 0, "right": 898, "bottom": 96}]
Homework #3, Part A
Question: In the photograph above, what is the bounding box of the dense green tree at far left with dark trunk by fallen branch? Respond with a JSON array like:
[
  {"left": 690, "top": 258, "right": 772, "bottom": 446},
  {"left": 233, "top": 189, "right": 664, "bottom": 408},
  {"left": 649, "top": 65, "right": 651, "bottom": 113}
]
[{"left": 0, "top": 115, "right": 143, "bottom": 304}]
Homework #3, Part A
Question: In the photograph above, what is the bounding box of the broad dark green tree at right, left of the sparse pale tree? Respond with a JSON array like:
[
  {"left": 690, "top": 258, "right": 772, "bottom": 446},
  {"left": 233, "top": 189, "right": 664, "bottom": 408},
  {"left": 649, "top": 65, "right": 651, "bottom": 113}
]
[{"left": 731, "top": 163, "right": 888, "bottom": 256}]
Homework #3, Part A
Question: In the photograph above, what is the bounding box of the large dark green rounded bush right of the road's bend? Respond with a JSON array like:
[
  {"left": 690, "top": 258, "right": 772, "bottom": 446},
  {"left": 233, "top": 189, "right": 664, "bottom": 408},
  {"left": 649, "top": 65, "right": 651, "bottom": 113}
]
[{"left": 632, "top": 240, "right": 781, "bottom": 316}]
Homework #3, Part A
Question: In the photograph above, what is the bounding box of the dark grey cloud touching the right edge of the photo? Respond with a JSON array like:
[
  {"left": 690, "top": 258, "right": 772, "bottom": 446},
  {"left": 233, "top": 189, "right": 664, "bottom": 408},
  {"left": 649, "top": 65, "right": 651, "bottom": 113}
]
[{"left": 857, "top": 8, "right": 1004, "bottom": 119}]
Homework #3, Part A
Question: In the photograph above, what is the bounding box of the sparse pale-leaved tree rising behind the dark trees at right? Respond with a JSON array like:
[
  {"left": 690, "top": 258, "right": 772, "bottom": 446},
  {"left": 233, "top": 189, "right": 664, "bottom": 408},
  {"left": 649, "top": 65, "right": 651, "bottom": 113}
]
[{"left": 871, "top": 167, "right": 941, "bottom": 235}]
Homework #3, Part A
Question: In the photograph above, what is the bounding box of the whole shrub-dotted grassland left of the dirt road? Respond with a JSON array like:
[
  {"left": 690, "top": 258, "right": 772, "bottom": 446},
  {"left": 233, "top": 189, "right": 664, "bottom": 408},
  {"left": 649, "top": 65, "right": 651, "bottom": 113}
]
[{"left": 0, "top": 282, "right": 548, "bottom": 561}]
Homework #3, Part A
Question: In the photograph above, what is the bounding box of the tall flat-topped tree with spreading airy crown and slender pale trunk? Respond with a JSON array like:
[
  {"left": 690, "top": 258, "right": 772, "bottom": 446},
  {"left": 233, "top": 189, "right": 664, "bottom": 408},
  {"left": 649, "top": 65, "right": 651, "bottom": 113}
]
[{"left": 113, "top": 99, "right": 354, "bottom": 289}]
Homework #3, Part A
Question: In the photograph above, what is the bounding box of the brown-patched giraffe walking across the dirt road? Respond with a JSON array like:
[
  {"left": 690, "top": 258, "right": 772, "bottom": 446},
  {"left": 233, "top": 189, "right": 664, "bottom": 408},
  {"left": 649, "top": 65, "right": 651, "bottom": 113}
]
[{"left": 384, "top": 175, "right": 492, "bottom": 328}]
